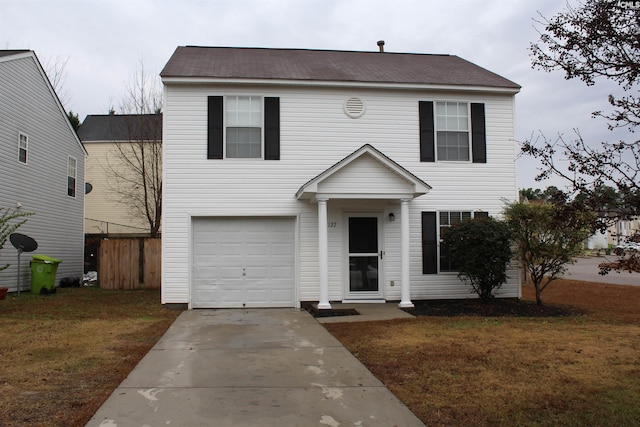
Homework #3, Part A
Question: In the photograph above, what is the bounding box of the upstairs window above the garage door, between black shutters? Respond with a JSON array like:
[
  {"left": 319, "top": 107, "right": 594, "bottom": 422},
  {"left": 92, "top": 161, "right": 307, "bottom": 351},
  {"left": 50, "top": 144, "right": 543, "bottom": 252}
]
[{"left": 225, "top": 96, "right": 262, "bottom": 158}]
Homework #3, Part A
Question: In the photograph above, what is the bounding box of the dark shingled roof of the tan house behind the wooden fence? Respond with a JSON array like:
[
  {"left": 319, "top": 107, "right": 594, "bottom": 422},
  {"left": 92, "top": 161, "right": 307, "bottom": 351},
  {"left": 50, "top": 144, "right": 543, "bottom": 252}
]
[{"left": 78, "top": 114, "right": 162, "bottom": 143}]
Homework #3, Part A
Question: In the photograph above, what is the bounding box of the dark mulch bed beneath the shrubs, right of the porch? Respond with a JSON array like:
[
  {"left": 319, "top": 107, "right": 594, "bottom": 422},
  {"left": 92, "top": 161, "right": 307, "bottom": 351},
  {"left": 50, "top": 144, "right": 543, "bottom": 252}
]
[{"left": 403, "top": 299, "right": 583, "bottom": 317}]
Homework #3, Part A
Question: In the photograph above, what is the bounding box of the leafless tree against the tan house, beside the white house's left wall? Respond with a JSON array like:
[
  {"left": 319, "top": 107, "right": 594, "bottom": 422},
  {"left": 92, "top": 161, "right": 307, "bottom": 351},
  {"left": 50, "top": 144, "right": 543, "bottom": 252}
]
[{"left": 105, "top": 62, "right": 162, "bottom": 237}]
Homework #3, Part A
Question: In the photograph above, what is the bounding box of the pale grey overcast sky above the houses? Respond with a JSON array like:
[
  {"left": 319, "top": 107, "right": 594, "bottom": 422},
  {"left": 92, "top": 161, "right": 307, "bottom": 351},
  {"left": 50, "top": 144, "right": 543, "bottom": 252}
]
[{"left": 0, "top": 0, "right": 616, "bottom": 188}]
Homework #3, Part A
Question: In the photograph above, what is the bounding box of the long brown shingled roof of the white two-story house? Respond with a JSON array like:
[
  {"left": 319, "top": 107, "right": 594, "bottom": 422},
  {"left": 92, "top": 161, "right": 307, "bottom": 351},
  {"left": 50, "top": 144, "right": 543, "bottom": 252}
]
[{"left": 160, "top": 46, "right": 520, "bottom": 91}]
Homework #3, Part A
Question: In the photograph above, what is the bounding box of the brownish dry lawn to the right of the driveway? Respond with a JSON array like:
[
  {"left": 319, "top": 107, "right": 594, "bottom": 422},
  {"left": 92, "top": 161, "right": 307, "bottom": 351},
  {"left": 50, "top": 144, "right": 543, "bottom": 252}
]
[{"left": 325, "top": 280, "right": 640, "bottom": 426}]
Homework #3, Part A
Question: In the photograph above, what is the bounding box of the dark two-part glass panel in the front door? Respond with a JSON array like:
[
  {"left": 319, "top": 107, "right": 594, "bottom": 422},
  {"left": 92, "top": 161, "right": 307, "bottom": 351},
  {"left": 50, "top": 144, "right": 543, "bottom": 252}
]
[{"left": 349, "top": 217, "right": 378, "bottom": 292}]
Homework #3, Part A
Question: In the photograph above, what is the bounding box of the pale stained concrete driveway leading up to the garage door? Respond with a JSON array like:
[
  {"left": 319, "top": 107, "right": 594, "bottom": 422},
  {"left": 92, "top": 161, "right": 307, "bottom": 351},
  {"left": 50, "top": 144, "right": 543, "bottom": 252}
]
[{"left": 87, "top": 309, "right": 424, "bottom": 427}]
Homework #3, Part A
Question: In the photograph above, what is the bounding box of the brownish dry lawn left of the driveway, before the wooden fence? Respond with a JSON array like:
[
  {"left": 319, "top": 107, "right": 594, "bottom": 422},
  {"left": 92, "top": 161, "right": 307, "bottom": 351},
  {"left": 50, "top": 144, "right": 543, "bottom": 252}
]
[{"left": 0, "top": 288, "right": 180, "bottom": 427}]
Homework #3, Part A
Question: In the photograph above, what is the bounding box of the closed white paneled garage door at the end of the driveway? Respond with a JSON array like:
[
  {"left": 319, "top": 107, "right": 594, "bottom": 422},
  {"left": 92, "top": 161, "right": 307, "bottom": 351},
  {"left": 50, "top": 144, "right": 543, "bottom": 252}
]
[{"left": 191, "top": 218, "right": 295, "bottom": 308}]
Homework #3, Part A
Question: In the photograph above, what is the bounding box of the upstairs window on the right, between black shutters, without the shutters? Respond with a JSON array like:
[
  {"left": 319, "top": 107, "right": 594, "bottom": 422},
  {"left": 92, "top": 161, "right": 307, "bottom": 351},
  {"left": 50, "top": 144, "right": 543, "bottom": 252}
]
[{"left": 435, "top": 101, "right": 470, "bottom": 161}]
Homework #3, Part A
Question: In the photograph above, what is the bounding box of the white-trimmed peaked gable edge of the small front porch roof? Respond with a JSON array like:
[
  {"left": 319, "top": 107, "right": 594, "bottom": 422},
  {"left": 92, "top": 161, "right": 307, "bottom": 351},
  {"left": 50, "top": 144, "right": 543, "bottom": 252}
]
[{"left": 296, "top": 144, "right": 431, "bottom": 200}]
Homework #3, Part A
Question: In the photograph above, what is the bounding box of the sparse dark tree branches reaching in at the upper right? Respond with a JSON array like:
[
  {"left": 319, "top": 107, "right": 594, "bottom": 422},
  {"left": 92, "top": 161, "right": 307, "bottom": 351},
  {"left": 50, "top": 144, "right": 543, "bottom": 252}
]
[{"left": 522, "top": 0, "right": 640, "bottom": 270}]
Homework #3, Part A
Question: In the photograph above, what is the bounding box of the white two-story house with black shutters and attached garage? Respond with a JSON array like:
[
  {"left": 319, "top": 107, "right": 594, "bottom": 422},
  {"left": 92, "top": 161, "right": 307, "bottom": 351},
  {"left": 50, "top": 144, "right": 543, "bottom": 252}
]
[{"left": 161, "top": 47, "right": 521, "bottom": 308}]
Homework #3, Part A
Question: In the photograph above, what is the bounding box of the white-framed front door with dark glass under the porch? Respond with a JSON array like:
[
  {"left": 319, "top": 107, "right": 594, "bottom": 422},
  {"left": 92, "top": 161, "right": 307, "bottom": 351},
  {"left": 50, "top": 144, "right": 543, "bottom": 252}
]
[{"left": 347, "top": 214, "right": 382, "bottom": 299}]
